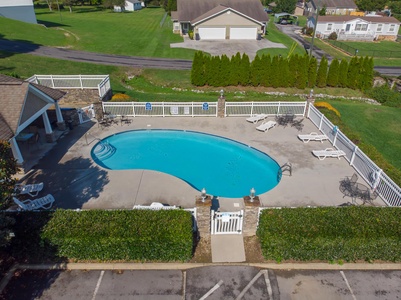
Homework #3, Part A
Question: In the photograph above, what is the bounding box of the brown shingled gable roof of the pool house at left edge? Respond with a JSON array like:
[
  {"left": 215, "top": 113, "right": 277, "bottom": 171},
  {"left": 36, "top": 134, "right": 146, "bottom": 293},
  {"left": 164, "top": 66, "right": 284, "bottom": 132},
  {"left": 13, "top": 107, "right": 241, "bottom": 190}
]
[{"left": 0, "top": 74, "right": 66, "bottom": 140}]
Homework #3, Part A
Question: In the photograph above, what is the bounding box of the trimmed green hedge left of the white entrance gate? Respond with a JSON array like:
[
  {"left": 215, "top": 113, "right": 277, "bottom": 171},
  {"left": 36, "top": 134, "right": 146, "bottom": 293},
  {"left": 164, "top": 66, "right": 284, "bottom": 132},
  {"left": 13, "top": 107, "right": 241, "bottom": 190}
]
[{"left": 42, "top": 210, "right": 193, "bottom": 261}]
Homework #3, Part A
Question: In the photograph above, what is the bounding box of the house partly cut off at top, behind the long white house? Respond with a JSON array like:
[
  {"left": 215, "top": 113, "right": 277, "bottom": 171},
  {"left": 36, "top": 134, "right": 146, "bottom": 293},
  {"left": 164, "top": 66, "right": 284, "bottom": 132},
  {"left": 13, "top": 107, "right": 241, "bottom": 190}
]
[{"left": 304, "top": 0, "right": 358, "bottom": 16}]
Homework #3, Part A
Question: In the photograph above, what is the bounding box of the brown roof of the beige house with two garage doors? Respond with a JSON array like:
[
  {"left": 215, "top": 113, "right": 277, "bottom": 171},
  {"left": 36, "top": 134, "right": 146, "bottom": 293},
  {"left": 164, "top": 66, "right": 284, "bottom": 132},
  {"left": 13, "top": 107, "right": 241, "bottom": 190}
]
[{"left": 177, "top": 0, "right": 269, "bottom": 23}]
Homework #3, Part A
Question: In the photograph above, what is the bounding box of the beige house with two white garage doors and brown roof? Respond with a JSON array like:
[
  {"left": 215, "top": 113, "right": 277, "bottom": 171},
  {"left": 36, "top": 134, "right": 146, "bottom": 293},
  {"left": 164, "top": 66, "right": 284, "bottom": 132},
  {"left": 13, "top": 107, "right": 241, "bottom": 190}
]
[{"left": 171, "top": 0, "right": 269, "bottom": 40}]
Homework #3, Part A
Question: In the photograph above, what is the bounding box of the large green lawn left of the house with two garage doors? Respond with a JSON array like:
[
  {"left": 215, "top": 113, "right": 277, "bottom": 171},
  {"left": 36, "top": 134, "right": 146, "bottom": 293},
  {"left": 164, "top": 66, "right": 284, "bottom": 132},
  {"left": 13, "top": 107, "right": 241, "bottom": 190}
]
[{"left": 0, "top": 7, "right": 195, "bottom": 59}]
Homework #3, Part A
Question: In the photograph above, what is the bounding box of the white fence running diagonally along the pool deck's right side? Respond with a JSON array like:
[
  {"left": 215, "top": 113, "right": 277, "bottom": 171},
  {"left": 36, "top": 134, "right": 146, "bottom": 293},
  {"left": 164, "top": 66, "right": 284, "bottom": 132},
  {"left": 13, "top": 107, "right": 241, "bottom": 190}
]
[{"left": 308, "top": 105, "right": 401, "bottom": 206}]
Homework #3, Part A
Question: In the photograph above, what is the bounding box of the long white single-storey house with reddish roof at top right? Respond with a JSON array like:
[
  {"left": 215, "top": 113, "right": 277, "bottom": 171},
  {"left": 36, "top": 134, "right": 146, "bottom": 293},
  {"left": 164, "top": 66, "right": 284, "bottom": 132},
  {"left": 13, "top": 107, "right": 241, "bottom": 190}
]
[{"left": 307, "top": 16, "right": 401, "bottom": 41}]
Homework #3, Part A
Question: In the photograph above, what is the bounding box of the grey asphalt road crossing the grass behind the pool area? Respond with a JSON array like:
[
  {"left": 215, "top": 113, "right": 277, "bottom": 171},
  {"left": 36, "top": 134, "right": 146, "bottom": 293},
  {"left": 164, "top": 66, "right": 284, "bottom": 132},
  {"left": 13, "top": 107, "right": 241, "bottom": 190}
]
[{"left": 0, "top": 38, "right": 401, "bottom": 76}]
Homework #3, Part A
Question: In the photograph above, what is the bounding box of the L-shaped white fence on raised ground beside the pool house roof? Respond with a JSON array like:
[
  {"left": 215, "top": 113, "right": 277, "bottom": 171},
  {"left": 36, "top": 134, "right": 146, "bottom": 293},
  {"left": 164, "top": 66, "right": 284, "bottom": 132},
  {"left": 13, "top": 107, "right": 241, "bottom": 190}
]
[{"left": 27, "top": 75, "right": 111, "bottom": 98}]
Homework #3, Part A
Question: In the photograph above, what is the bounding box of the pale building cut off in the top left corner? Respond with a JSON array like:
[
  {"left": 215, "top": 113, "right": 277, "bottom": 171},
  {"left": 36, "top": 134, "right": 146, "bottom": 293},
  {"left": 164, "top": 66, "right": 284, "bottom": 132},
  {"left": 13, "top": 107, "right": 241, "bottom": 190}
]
[{"left": 0, "top": 0, "right": 38, "bottom": 24}]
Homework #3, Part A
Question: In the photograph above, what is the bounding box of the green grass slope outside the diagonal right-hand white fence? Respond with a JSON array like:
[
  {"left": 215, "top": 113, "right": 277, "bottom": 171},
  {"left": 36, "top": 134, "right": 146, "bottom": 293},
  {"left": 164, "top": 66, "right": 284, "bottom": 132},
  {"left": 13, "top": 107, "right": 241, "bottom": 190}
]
[{"left": 329, "top": 101, "right": 401, "bottom": 170}]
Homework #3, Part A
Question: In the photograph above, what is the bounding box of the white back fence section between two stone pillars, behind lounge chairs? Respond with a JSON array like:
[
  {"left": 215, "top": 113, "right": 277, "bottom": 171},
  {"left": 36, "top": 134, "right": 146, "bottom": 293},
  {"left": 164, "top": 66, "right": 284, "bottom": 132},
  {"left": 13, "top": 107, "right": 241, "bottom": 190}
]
[{"left": 225, "top": 101, "right": 307, "bottom": 117}]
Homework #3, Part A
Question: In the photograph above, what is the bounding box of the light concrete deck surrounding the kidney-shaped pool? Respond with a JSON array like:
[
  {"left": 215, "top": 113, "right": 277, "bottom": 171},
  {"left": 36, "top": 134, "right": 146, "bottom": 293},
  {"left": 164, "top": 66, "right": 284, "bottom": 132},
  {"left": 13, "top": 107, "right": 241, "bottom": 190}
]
[{"left": 19, "top": 117, "right": 384, "bottom": 211}]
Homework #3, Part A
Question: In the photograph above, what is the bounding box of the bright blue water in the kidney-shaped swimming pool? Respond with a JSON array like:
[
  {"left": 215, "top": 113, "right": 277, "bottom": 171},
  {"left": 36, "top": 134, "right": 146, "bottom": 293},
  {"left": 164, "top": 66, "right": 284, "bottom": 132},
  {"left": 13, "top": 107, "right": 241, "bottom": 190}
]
[{"left": 91, "top": 130, "right": 281, "bottom": 198}]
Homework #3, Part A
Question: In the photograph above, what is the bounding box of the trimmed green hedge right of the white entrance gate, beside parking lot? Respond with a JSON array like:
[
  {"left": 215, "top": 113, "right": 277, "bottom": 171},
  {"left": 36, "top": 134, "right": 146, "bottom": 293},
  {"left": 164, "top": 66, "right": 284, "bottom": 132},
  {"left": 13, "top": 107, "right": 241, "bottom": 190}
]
[{"left": 257, "top": 206, "right": 401, "bottom": 262}]
